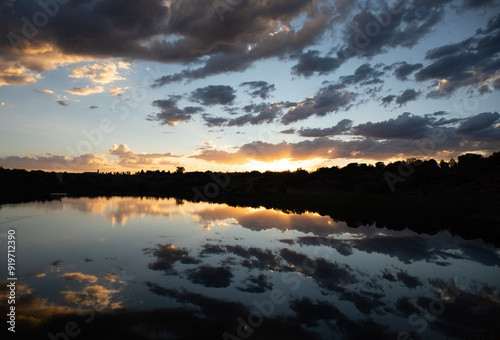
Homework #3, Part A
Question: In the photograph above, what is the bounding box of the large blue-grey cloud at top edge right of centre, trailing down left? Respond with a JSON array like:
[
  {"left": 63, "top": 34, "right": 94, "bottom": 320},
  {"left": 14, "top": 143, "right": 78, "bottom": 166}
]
[{"left": 290, "top": 1, "right": 450, "bottom": 77}]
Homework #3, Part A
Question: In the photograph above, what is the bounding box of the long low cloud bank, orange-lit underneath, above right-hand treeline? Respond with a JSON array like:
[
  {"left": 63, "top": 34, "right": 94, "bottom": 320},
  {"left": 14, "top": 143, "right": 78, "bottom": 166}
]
[{"left": 190, "top": 112, "right": 500, "bottom": 165}]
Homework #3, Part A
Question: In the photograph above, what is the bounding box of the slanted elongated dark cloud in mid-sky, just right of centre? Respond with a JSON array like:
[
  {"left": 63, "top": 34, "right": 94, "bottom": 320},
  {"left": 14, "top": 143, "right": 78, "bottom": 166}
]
[{"left": 281, "top": 85, "right": 355, "bottom": 125}]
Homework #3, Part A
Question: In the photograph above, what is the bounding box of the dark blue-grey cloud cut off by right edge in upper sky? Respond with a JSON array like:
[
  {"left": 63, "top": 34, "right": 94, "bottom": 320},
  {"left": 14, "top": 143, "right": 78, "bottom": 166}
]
[{"left": 415, "top": 14, "right": 500, "bottom": 98}]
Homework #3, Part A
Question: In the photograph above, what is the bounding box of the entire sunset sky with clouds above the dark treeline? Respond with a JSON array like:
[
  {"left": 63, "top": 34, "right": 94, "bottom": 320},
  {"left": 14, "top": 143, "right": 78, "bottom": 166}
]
[{"left": 0, "top": 0, "right": 500, "bottom": 172}]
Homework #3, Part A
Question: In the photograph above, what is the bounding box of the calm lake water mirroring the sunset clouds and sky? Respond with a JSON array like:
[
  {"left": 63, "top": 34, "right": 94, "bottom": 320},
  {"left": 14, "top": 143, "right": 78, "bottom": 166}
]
[{"left": 0, "top": 197, "right": 500, "bottom": 339}]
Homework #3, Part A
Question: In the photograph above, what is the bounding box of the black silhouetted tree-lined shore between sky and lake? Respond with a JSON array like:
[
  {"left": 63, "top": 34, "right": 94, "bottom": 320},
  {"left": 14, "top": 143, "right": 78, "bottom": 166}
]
[{"left": 0, "top": 153, "right": 500, "bottom": 246}]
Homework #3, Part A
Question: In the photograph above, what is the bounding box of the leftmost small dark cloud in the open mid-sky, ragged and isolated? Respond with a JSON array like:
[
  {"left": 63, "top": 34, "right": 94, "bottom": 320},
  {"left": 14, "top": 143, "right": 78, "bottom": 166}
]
[{"left": 146, "top": 97, "right": 203, "bottom": 125}]
